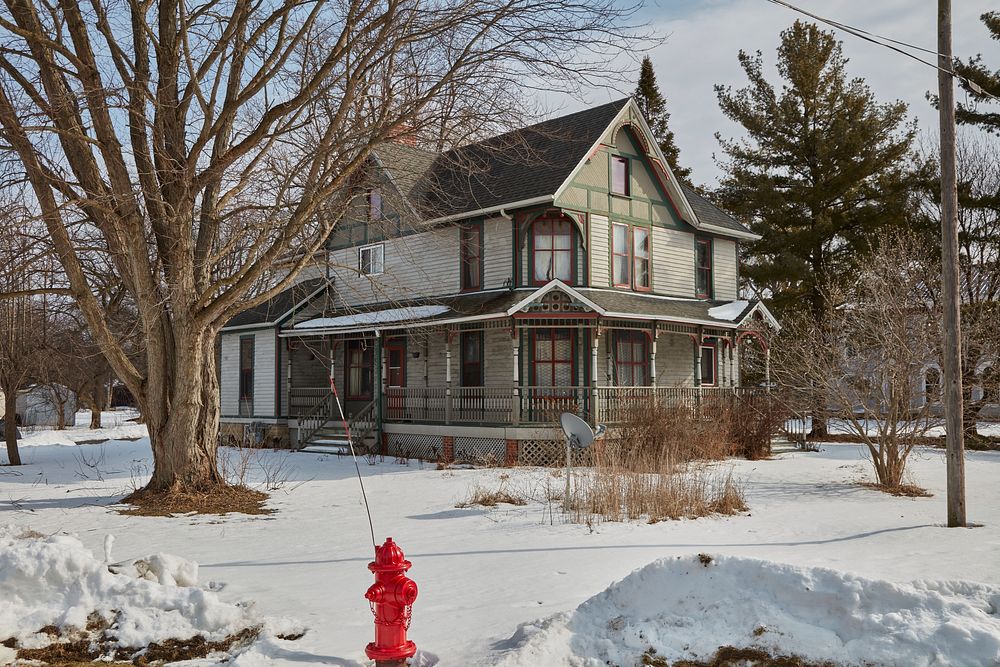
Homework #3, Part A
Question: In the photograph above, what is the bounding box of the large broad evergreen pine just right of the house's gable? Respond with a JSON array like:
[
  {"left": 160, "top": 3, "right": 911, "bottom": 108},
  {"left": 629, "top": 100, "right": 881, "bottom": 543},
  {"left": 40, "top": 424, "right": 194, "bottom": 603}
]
[{"left": 715, "top": 21, "right": 916, "bottom": 322}]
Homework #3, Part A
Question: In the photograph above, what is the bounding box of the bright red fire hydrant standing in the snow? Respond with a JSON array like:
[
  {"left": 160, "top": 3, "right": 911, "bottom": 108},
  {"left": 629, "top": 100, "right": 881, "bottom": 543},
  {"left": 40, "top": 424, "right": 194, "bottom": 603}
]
[{"left": 365, "top": 537, "right": 417, "bottom": 667}]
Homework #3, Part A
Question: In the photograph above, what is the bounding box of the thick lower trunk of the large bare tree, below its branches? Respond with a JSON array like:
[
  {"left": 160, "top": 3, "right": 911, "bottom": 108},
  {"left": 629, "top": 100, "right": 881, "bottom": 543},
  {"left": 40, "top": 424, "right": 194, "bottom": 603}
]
[{"left": 139, "top": 331, "right": 225, "bottom": 492}]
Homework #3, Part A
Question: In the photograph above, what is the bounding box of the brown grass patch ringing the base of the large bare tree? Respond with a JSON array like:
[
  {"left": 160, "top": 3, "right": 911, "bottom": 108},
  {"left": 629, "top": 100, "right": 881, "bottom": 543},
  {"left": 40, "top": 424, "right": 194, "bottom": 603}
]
[{"left": 119, "top": 485, "right": 274, "bottom": 516}]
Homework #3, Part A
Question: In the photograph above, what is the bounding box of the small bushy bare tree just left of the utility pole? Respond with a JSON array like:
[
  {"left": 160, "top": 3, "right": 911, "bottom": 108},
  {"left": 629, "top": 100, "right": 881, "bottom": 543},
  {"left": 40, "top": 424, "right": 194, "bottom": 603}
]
[{"left": 772, "top": 237, "right": 940, "bottom": 490}]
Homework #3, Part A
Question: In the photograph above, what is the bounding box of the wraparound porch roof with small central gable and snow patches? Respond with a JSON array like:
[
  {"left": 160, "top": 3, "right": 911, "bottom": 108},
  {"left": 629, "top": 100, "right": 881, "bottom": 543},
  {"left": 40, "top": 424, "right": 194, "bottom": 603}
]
[{"left": 281, "top": 281, "right": 766, "bottom": 336}]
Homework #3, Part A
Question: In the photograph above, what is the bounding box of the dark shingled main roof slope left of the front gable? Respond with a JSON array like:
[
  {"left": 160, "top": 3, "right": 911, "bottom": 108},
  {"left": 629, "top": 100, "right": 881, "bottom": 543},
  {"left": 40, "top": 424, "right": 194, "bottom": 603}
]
[{"left": 420, "top": 98, "right": 628, "bottom": 218}]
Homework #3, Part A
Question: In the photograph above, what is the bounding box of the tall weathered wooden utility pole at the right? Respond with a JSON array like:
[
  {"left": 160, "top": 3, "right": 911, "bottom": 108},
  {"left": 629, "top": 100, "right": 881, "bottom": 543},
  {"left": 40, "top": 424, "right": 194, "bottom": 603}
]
[{"left": 938, "top": 0, "right": 965, "bottom": 528}]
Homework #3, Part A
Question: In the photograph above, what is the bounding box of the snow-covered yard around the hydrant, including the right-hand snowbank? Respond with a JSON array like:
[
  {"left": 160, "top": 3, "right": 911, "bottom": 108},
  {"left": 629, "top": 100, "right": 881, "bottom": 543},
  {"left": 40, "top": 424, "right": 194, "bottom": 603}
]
[{"left": 0, "top": 414, "right": 1000, "bottom": 667}]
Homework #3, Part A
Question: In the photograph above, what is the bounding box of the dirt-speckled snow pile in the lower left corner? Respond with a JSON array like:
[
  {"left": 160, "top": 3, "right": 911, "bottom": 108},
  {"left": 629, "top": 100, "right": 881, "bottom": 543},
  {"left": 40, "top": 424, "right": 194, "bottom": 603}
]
[{"left": 0, "top": 526, "right": 260, "bottom": 648}]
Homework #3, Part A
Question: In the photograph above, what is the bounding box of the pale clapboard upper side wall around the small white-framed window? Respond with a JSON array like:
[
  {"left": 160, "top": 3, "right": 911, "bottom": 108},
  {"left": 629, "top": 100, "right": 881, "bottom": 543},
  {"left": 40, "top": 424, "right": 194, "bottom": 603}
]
[{"left": 330, "top": 226, "right": 460, "bottom": 306}]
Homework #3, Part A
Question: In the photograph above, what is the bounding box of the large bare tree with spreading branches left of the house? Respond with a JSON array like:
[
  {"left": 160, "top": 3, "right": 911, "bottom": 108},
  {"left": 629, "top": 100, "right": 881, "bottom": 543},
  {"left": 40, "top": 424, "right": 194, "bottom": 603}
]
[{"left": 0, "top": 0, "right": 636, "bottom": 492}]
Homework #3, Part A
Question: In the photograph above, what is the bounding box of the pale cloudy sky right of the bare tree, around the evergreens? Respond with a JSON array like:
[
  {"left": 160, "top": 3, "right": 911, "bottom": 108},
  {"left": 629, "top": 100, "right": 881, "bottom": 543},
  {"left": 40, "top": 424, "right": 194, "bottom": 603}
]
[{"left": 560, "top": 0, "right": 1000, "bottom": 185}]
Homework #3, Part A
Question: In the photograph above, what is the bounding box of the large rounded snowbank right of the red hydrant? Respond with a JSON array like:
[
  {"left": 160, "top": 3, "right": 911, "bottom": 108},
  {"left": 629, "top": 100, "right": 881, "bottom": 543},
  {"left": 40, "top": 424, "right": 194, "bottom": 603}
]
[{"left": 498, "top": 557, "right": 1000, "bottom": 667}]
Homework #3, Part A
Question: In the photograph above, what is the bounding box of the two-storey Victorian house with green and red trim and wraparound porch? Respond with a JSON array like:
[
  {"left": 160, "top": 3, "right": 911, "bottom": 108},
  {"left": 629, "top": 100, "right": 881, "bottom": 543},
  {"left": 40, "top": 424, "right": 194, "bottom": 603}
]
[{"left": 220, "top": 100, "right": 777, "bottom": 463}]
